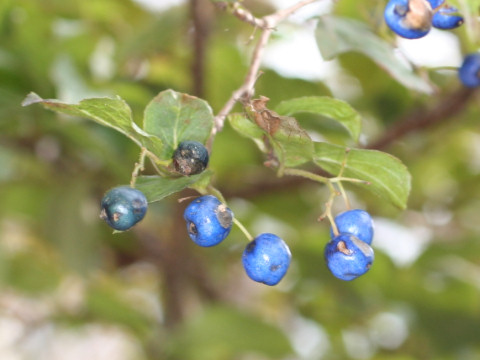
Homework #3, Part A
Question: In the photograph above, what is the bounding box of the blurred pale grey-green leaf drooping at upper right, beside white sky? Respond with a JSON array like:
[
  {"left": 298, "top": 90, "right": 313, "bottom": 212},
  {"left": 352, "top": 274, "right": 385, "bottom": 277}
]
[{"left": 316, "top": 16, "right": 433, "bottom": 94}]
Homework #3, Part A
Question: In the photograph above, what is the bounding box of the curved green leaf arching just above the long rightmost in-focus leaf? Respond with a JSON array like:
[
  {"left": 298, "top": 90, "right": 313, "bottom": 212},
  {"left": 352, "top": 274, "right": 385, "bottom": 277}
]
[{"left": 275, "top": 96, "right": 362, "bottom": 141}]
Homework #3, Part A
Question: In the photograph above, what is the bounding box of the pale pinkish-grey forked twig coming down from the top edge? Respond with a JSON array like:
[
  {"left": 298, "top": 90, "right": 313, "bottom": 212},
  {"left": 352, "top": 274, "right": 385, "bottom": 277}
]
[{"left": 211, "top": 0, "right": 319, "bottom": 138}]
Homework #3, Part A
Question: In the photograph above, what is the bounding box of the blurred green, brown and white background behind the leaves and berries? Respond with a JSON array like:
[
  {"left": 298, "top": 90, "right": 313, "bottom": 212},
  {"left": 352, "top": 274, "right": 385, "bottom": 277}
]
[{"left": 0, "top": 0, "right": 480, "bottom": 360}]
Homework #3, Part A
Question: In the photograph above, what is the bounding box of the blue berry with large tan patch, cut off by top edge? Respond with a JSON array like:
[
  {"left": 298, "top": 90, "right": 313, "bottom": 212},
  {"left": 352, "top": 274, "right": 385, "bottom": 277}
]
[{"left": 384, "top": 0, "right": 432, "bottom": 39}]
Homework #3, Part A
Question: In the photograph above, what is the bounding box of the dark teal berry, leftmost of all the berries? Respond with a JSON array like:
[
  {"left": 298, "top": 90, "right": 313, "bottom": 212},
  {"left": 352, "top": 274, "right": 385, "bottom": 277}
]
[{"left": 100, "top": 186, "right": 148, "bottom": 231}]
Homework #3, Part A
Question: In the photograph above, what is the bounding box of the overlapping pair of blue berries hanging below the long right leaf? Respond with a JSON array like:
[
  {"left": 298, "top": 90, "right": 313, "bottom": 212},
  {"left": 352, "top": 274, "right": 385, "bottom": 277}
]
[{"left": 325, "top": 209, "right": 374, "bottom": 281}]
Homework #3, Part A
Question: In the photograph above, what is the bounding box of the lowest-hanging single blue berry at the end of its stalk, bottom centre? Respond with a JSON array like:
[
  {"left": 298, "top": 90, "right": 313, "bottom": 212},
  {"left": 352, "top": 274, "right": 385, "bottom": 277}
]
[{"left": 242, "top": 233, "right": 292, "bottom": 286}]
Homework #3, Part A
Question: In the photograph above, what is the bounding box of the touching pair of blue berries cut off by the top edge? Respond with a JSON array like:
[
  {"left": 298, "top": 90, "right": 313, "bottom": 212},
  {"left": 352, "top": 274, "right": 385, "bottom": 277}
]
[{"left": 384, "top": 0, "right": 463, "bottom": 39}]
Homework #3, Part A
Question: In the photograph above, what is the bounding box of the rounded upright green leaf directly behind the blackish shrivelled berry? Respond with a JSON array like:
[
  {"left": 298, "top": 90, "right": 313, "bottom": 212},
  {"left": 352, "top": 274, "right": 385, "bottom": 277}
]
[{"left": 143, "top": 90, "right": 214, "bottom": 159}]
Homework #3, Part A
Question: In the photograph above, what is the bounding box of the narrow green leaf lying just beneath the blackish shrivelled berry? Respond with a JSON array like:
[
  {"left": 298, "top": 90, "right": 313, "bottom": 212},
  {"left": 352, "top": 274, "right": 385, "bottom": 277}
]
[{"left": 135, "top": 170, "right": 211, "bottom": 202}]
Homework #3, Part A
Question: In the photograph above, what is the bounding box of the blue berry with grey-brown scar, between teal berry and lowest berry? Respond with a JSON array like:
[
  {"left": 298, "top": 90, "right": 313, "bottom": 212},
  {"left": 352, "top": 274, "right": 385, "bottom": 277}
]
[{"left": 183, "top": 195, "right": 233, "bottom": 247}]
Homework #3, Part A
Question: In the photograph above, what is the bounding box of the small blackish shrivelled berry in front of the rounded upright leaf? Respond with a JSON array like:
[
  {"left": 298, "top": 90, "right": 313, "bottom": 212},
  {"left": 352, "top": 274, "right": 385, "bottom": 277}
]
[{"left": 173, "top": 141, "right": 209, "bottom": 176}]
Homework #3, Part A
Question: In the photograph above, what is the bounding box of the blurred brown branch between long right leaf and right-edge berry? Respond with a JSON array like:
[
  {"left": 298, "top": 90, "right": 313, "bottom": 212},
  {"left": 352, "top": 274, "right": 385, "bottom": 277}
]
[{"left": 366, "top": 87, "right": 476, "bottom": 150}]
